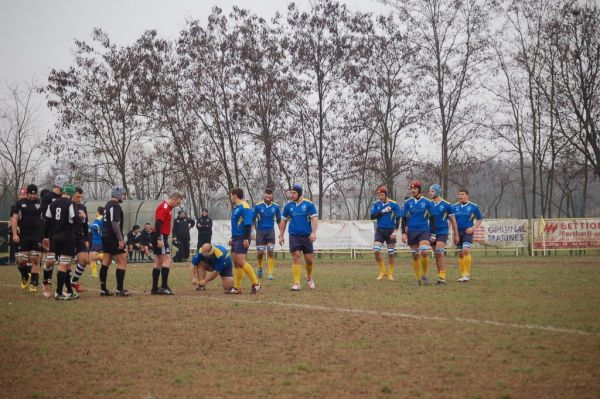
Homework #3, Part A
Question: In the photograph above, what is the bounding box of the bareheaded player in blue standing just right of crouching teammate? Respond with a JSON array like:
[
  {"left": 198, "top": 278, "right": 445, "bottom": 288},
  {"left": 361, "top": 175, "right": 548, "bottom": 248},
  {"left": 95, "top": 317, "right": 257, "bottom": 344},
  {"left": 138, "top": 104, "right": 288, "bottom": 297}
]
[{"left": 227, "top": 188, "right": 260, "bottom": 294}]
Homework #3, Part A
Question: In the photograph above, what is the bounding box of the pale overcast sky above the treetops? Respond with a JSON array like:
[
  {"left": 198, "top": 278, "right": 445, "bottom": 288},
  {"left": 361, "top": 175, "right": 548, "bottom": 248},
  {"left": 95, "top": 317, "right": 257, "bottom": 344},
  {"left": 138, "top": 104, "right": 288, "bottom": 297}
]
[{"left": 0, "top": 0, "right": 386, "bottom": 89}]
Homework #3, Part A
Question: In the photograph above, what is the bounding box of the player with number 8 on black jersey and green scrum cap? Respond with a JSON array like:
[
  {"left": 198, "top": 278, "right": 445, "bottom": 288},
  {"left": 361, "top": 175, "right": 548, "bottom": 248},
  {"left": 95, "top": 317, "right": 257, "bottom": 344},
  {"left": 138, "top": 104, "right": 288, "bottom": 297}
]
[{"left": 44, "top": 183, "right": 79, "bottom": 300}]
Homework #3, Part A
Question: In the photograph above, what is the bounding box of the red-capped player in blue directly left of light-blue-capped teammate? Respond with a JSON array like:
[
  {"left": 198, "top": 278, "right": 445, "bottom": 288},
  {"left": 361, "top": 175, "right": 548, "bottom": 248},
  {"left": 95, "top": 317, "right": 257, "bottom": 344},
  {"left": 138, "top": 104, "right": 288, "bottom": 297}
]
[{"left": 402, "top": 180, "right": 435, "bottom": 285}]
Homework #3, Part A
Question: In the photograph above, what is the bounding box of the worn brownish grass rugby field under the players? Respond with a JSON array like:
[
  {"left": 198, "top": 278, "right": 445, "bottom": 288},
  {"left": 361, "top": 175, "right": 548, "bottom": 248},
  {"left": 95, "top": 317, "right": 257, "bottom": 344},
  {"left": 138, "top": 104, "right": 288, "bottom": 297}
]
[{"left": 0, "top": 256, "right": 600, "bottom": 398}]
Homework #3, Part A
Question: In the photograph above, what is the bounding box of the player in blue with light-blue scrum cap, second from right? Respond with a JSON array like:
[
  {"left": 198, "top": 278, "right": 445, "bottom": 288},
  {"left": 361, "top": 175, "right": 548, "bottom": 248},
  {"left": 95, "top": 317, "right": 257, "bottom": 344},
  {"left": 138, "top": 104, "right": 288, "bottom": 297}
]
[{"left": 429, "top": 184, "right": 458, "bottom": 284}]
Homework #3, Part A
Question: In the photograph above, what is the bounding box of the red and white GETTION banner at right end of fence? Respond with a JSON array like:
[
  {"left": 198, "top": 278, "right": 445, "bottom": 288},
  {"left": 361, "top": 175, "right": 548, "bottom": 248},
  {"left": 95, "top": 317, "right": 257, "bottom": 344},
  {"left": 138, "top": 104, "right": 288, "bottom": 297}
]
[{"left": 533, "top": 219, "right": 600, "bottom": 249}]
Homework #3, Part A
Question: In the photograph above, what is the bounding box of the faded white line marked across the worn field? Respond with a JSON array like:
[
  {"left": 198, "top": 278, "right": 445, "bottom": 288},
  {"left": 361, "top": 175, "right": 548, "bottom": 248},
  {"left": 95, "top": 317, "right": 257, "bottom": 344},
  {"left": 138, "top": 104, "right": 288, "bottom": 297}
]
[{"left": 0, "top": 284, "right": 600, "bottom": 337}]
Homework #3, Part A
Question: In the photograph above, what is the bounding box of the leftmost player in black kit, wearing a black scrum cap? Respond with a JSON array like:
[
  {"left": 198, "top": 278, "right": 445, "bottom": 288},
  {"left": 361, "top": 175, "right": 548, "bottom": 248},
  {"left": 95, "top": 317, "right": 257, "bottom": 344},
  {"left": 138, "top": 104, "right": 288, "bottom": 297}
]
[{"left": 11, "top": 184, "right": 43, "bottom": 292}]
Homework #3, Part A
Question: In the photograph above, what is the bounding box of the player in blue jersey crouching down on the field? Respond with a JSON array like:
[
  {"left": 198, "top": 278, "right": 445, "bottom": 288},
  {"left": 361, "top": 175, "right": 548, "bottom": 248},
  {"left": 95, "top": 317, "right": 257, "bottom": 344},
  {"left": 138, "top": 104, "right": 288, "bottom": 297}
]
[{"left": 192, "top": 244, "right": 233, "bottom": 291}]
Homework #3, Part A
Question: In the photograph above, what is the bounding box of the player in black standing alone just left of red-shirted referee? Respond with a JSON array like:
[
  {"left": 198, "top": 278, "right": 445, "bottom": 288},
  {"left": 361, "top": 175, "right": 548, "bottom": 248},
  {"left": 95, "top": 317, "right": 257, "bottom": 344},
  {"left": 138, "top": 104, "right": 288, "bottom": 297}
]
[{"left": 100, "top": 187, "right": 129, "bottom": 296}]
